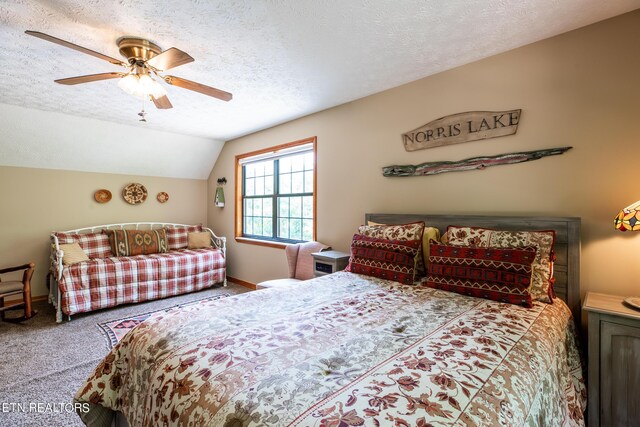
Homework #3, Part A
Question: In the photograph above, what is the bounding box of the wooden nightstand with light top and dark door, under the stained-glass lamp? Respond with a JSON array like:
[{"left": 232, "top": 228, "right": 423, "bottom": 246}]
[{"left": 582, "top": 292, "right": 640, "bottom": 427}]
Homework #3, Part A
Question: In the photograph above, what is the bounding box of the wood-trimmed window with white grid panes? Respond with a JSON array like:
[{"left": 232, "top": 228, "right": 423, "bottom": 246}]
[{"left": 236, "top": 137, "right": 316, "bottom": 246}]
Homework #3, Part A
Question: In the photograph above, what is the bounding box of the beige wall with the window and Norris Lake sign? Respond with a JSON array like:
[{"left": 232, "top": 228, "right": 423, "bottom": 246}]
[{"left": 208, "top": 11, "right": 640, "bottom": 295}]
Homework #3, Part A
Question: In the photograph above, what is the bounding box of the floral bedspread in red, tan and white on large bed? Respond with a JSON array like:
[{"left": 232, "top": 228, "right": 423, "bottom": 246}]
[{"left": 75, "top": 272, "right": 586, "bottom": 427}]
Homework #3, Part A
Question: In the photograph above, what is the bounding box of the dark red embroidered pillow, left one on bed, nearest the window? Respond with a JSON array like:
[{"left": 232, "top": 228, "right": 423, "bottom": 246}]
[{"left": 345, "top": 234, "right": 421, "bottom": 285}]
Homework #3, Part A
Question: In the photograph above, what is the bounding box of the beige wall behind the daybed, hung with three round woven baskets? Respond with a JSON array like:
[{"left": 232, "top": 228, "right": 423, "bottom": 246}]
[{"left": 0, "top": 166, "right": 207, "bottom": 296}]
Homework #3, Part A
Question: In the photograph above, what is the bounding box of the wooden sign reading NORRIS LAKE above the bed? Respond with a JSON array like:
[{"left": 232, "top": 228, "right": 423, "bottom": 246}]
[{"left": 402, "top": 110, "right": 522, "bottom": 151}]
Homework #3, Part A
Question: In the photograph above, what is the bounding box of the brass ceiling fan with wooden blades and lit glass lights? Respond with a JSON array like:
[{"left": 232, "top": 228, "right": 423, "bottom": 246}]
[{"left": 25, "top": 30, "right": 232, "bottom": 109}]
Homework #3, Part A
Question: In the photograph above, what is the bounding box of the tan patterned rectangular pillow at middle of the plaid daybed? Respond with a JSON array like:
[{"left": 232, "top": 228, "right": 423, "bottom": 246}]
[{"left": 103, "top": 228, "right": 168, "bottom": 256}]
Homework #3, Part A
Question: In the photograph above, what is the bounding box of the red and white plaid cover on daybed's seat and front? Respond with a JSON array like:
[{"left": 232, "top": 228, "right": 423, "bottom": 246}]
[{"left": 60, "top": 248, "right": 225, "bottom": 315}]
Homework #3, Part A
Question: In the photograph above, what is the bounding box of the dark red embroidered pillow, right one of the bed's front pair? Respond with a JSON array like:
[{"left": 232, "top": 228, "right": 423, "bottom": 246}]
[{"left": 424, "top": 243, "right": 536, "bottom": 307}]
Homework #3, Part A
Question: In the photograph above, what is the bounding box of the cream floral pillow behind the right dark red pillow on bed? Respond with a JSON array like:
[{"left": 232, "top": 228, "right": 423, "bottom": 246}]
[{"left": 446, "top": 225, "right": 556, "bottom": 303}]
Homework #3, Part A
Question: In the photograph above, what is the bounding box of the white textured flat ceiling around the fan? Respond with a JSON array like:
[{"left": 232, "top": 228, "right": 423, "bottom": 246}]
[{"left": 0, "top": 0, "right": 640, "bottom": 176}]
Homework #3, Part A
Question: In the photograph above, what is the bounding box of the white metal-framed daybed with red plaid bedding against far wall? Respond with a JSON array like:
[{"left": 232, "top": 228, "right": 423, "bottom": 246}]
[{"left": 48, "top": 226, "right": 227, "bottom": 323}]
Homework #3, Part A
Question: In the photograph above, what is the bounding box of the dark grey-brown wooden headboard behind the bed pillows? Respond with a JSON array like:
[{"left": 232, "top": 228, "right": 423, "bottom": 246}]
[{"left": 365, "top": 213, "right": 580, "bottom": 325}]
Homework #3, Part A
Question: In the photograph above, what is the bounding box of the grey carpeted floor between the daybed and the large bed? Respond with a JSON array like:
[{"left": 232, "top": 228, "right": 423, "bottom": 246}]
[{"left": 0, "top": 283, "right": 248, "bottom": 426}]
